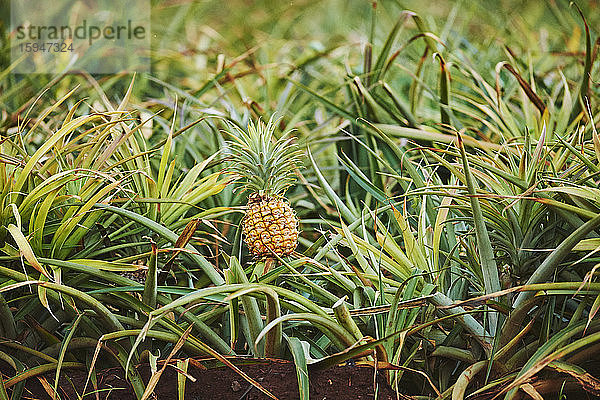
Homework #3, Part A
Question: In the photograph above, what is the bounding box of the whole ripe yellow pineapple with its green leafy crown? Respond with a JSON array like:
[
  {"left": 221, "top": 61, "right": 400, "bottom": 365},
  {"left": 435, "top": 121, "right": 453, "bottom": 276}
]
[{"left": 228, "top": 119, "right": 302, "bottom": 258}]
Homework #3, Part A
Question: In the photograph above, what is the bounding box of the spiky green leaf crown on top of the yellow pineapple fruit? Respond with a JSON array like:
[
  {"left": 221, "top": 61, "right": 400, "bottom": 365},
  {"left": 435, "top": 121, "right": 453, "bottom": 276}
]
[{"left": 227, "top": 117, "right": 303, "bottom": 196}]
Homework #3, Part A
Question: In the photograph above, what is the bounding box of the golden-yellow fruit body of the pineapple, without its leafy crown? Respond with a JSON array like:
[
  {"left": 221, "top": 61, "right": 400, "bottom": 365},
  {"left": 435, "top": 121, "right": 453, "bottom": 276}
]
[{"left": 242, "top": 194, "right": 298, "bottom": 257}]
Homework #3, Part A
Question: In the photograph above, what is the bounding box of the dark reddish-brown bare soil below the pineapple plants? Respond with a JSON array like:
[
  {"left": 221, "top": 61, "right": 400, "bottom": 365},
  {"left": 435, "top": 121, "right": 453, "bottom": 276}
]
[{"left": 7, "top": 360, "right": 408, "bottom": 400}]
